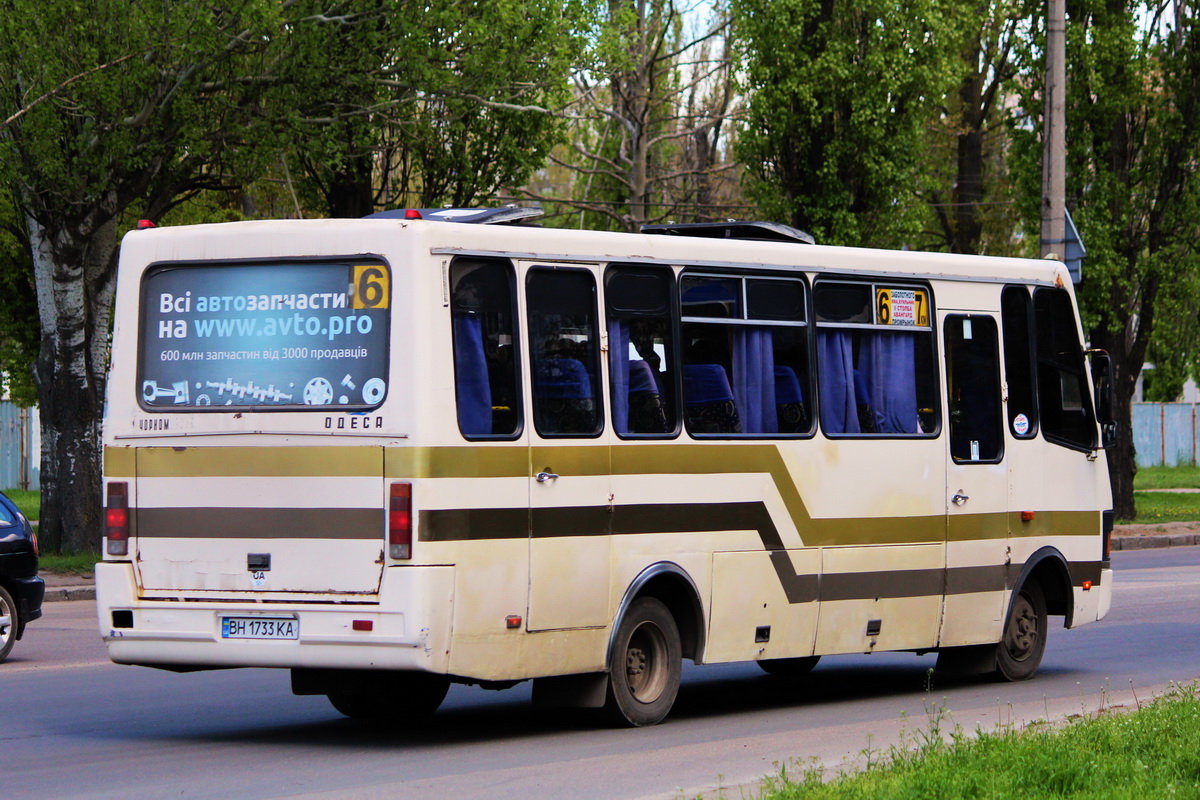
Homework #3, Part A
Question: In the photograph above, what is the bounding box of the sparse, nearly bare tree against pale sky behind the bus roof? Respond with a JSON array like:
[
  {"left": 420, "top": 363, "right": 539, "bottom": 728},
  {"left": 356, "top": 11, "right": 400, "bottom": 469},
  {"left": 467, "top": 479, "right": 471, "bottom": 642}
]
[{"left": 522, "top": 0, "right": 738, "bottom": 230}]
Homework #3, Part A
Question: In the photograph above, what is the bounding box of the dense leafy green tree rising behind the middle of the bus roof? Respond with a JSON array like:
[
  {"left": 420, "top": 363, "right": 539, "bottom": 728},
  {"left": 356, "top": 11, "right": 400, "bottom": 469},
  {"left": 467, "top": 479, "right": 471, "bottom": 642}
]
[{"left": 732, "top": 0, "right": 977, "bottom": 246}]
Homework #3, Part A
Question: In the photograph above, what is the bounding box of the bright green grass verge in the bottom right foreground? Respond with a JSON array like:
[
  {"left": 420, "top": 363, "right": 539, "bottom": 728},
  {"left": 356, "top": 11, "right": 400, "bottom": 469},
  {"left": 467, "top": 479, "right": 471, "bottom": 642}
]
[{"left": 761, "top": 685, "right": 1200, "bottom": 800}]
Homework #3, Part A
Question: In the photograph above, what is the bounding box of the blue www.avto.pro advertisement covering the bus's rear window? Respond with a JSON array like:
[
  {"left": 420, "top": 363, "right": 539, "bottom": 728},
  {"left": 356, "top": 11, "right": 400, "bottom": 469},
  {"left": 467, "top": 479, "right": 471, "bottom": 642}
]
[{"left": 138, "top": 260, "right": 391, "bottom": 411}]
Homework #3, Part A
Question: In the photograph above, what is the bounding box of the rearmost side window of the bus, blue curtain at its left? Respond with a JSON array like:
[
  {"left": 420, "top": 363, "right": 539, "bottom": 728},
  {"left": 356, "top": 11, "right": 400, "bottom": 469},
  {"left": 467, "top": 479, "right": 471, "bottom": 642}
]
[{"left": 450, "top": 259, "right": 521, "bottom": 439}]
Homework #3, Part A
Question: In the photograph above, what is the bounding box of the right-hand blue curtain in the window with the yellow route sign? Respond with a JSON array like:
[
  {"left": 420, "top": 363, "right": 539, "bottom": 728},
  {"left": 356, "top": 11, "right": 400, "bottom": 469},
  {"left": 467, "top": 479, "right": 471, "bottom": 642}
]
[{"left": 858, "top": 331, "right": 918, "bottom": 433}]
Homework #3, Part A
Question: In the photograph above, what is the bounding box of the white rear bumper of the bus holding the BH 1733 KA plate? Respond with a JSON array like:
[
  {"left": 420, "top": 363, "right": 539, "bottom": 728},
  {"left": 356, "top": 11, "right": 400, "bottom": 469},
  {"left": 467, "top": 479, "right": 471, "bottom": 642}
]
[{"left": 96, "top": 563, "right": 454, "bottom": 673}]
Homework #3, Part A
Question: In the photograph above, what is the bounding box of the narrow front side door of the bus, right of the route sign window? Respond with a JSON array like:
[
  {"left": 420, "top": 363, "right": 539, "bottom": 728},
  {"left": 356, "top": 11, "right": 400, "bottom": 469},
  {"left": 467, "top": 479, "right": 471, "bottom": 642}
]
[{"left": 938, "top": 313, "right": 1009, "bottom": 646}]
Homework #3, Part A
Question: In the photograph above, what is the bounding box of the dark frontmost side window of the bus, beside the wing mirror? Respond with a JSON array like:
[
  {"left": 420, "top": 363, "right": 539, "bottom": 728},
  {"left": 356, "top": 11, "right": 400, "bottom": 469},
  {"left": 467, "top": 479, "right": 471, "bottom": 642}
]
[{"left": 1033, "top": 288, "right": 1096, "bottom": 450}]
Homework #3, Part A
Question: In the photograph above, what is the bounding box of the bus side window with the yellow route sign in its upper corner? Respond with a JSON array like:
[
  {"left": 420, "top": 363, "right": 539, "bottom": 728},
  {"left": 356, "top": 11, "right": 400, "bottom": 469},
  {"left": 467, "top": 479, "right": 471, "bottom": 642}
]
[{"left": 812, "top": 281, "right": 938, "bottom": 437}]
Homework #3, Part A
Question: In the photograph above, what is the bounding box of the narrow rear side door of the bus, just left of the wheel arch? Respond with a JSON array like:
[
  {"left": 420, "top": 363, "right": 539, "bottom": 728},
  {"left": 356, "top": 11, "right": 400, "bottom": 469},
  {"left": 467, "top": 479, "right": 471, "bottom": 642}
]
[{"left": 526, "top": 264, "right": 612, "bottom": 631}]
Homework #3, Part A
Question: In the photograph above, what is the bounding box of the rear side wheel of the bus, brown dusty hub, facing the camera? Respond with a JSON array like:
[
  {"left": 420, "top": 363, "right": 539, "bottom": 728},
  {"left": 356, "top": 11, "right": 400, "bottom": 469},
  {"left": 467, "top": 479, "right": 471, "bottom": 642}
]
[{"left": 605, "top": 597, "right": 683, "bottom": 728}]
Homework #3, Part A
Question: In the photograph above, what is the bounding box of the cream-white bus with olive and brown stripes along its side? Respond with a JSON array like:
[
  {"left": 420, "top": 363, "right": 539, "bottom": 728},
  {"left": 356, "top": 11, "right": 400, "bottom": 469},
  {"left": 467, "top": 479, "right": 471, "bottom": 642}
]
[{"left": 96, "top": 209, "right": 1112, "bottom": 726}]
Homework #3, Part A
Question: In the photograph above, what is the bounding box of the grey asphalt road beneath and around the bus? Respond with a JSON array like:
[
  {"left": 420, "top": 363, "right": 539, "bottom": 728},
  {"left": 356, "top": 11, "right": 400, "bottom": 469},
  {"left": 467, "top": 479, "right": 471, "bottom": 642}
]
[{"left": 0, "top": 547, "right": 1200, "bottom": 800}]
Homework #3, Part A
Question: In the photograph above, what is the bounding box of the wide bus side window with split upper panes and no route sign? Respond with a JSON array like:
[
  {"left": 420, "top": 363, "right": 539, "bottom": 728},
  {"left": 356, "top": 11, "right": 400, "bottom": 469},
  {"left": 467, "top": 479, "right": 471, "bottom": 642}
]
[{"left": 680, "top": 273, "right": 812, "bottom": 437}]
